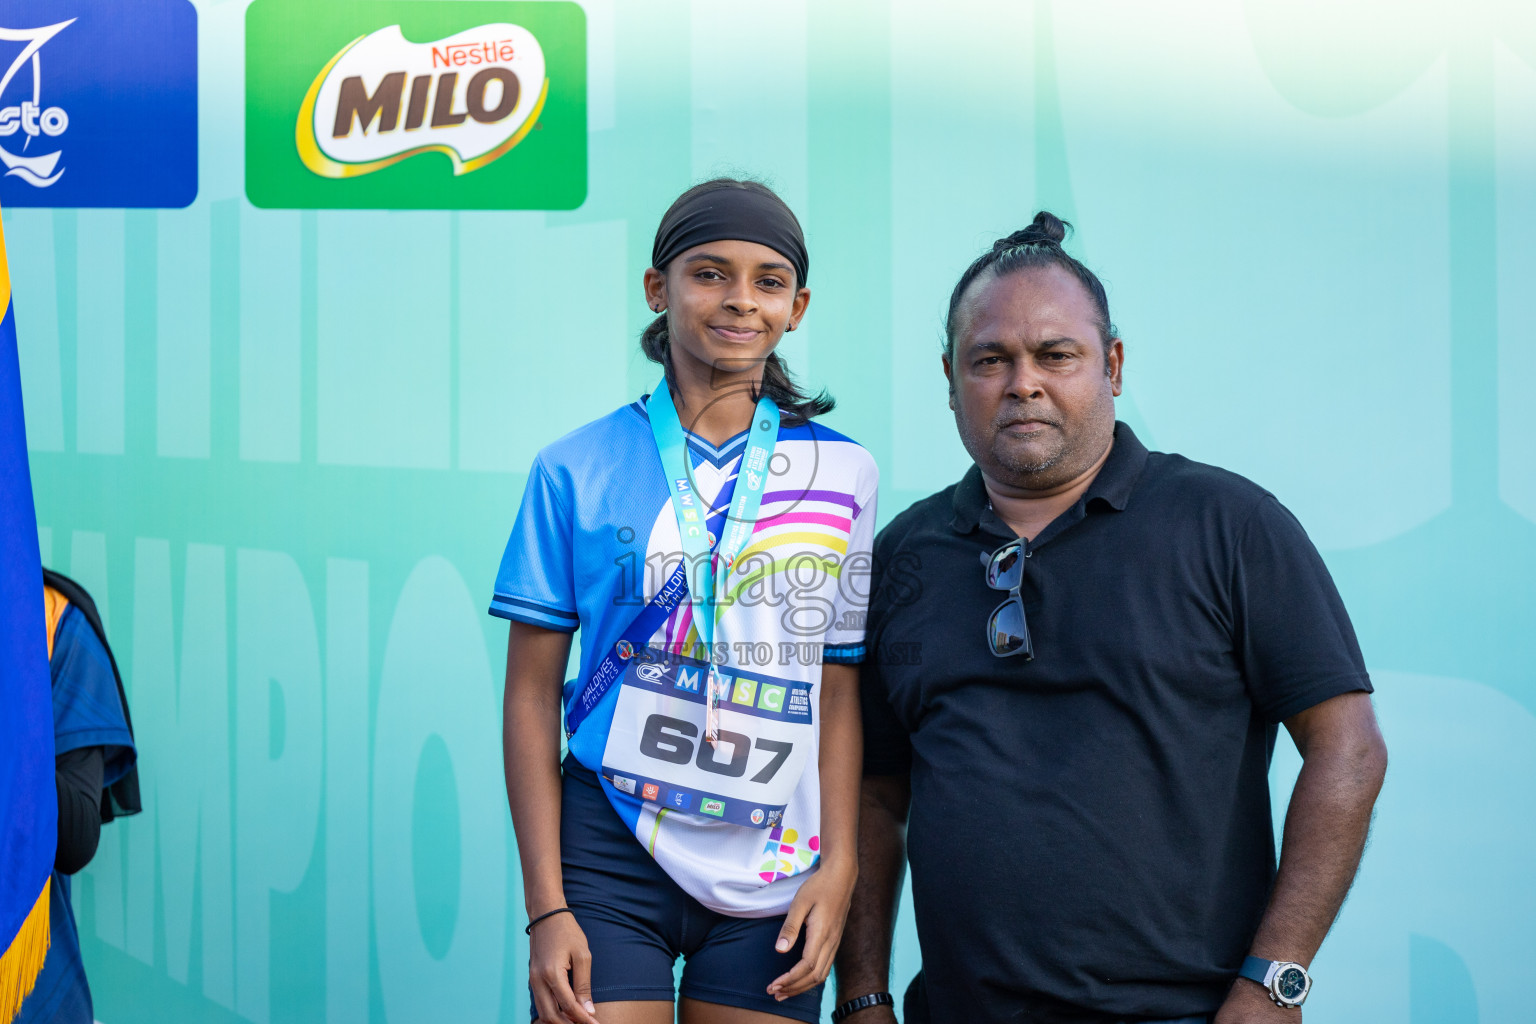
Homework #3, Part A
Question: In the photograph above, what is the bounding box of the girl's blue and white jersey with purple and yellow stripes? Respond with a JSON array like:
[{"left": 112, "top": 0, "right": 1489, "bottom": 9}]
[{"left": 490, "top": 401, "right": 879, "bottom": 917}]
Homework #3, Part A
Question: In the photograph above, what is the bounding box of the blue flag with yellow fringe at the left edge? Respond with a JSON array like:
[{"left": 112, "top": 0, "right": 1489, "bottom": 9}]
[{"left": 0, "top": 210, "right": 58, "bottom": 1024}]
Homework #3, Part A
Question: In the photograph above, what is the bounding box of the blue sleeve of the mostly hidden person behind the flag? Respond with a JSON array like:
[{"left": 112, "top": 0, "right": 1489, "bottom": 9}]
[{"left": 48, "top": 606, "right": 137, "bottom": 786}]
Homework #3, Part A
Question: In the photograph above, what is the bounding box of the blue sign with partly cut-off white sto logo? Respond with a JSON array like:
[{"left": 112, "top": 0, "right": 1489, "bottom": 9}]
[{"left": 0, "top": 0, "right": 197, "bottom": 207}]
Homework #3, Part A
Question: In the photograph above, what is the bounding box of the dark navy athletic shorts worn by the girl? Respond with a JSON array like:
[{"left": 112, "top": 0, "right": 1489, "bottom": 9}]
[{"left": 530, "top": 757, "right": 822, "bottom": 1024}]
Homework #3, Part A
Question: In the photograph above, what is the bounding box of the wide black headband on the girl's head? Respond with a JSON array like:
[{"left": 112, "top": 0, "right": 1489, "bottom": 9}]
[{"left": 651, "top": 186, "right": 811, "bottom": 289}]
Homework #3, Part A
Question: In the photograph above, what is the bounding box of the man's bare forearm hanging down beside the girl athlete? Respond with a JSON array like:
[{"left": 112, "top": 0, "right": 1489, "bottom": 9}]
[{"left": 837, "top": 772, "right": 912, "bottom": 1024}]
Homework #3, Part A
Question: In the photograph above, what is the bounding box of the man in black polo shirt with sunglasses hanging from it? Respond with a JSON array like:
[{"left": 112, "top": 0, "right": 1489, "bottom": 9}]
[{"left": 834, "top": 213, "right": 1385, "bottom": 1024}]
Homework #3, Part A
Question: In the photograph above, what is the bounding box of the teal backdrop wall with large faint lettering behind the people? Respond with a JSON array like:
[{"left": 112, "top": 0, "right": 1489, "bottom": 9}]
[{"left": 5, "top": 0, "right": 1536, "bottom": 1024}]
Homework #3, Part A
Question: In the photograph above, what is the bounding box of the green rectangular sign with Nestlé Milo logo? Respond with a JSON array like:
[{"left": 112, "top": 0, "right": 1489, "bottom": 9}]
[{"left": 246, "top": 0, "right": 587, "bottom": 209}]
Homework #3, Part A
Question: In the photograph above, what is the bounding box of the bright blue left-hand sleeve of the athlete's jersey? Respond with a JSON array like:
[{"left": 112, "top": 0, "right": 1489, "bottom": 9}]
[{"left": 490, "top": 454, "right": 581, "bottom": 633}]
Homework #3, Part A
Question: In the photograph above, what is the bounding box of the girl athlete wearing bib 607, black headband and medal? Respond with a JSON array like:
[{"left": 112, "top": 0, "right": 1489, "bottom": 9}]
[{"left": 492, "top": 178, "right": 876, "bottom": 1024}]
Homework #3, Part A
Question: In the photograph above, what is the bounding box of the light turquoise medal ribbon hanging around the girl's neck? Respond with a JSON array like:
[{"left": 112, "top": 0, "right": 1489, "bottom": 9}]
[{"left": 647, "top": 379, "right": 779, "bottom": 745}]
